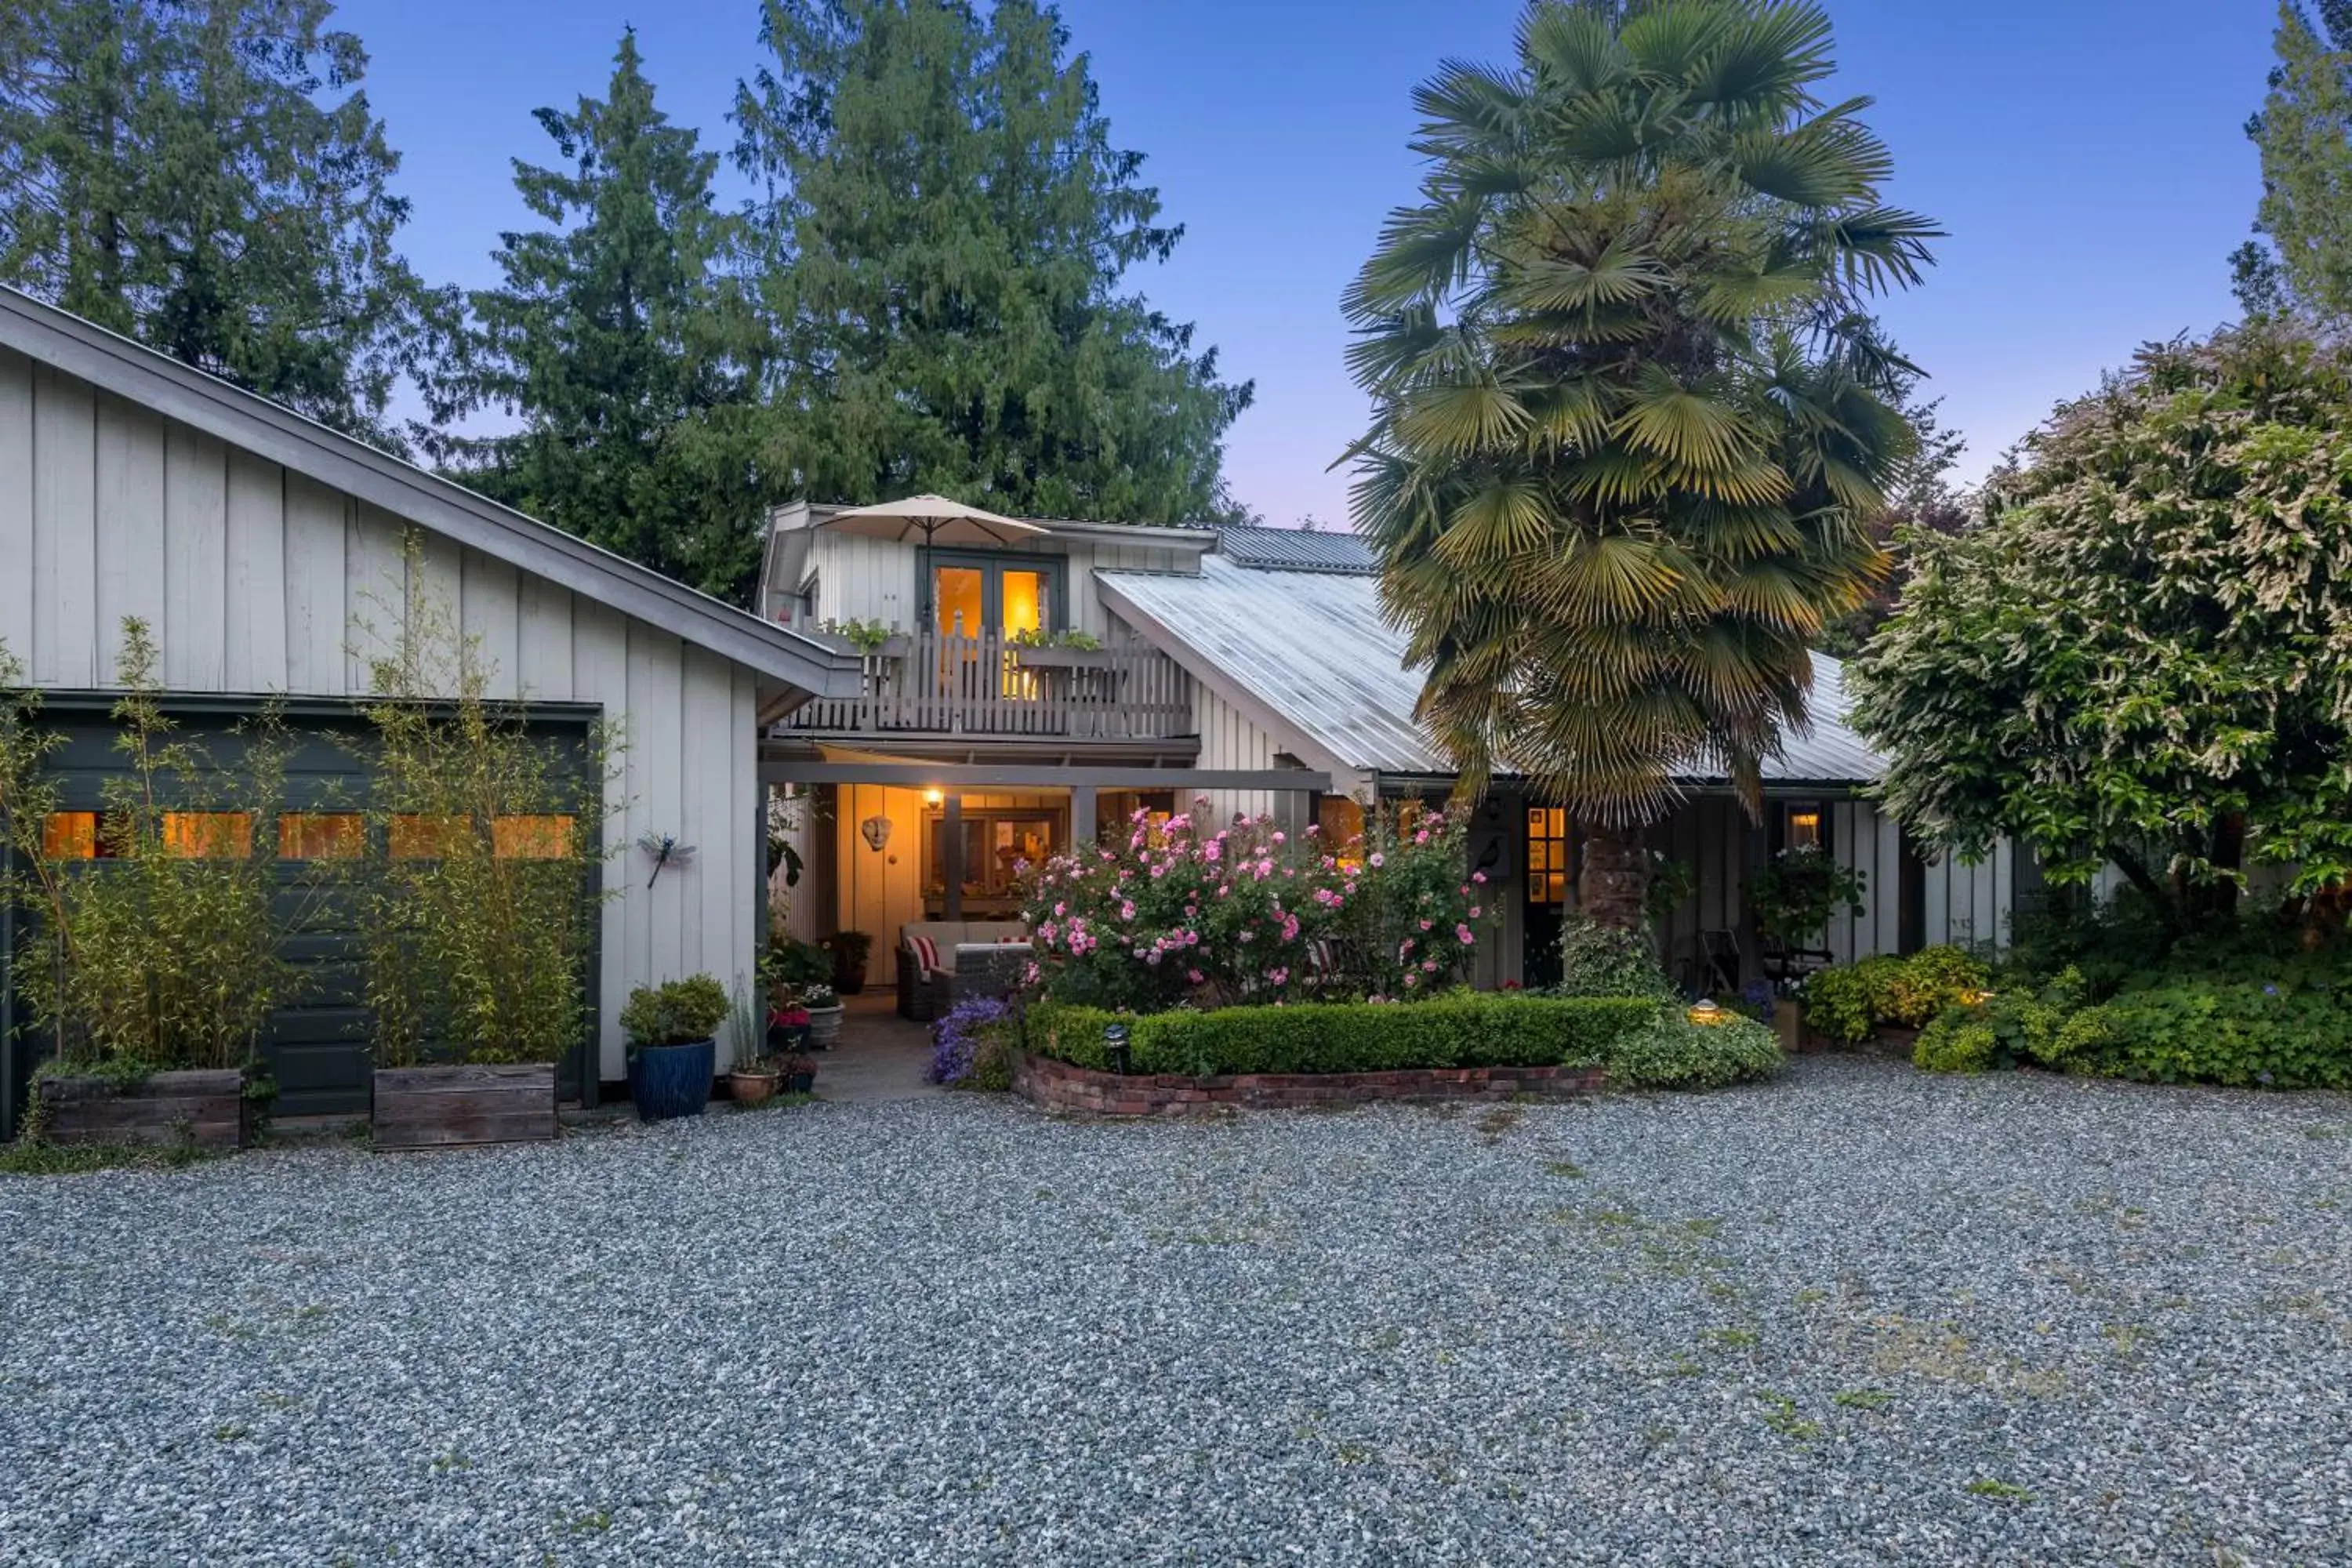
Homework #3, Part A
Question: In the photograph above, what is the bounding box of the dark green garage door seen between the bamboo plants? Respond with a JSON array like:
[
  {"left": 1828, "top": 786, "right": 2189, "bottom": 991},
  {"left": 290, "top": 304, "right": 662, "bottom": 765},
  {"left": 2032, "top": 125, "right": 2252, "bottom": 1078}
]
[{"left": 0, "top": 699, "right": 595, "bottom": 1138}]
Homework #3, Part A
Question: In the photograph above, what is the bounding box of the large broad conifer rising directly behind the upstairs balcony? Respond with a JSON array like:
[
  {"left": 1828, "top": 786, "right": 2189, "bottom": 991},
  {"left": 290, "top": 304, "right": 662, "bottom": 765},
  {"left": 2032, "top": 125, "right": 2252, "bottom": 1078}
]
[{"left": 734, "top": 0, "right": 1251, "bottom": 522}]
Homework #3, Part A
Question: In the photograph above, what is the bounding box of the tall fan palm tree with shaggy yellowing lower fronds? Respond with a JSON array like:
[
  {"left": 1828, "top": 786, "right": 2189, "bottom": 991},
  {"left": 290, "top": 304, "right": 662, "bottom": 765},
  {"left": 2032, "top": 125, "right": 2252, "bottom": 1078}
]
[{"left": 1345, "top": 0, "right": 1940, "bottom": 926}]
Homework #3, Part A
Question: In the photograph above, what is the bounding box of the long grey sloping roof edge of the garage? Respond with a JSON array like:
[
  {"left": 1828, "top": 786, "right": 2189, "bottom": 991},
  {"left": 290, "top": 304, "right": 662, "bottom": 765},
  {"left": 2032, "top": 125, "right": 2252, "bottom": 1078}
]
[{"left": 0, "top": 285, "right": 861, "bottom": 696}]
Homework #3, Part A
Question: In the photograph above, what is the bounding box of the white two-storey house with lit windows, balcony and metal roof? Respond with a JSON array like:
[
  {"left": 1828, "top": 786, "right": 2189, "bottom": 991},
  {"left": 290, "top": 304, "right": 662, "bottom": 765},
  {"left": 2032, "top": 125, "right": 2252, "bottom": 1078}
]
[{"left": 762, "top": 506, "right": 2030, "bottom": 987}]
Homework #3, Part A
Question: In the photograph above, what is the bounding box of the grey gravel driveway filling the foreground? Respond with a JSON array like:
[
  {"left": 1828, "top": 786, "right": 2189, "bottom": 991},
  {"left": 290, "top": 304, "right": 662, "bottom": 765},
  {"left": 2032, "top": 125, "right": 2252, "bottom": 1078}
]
[{"left": 0, "top": 1058, "right": 2352, "bottom": 1563}]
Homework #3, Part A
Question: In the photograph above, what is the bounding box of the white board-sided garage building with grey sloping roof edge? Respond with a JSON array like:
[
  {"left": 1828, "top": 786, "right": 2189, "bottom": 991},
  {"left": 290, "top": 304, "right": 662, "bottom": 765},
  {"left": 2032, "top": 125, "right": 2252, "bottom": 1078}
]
[{"left": 0, "top": 289, "right": 861, "bottom": 1135}]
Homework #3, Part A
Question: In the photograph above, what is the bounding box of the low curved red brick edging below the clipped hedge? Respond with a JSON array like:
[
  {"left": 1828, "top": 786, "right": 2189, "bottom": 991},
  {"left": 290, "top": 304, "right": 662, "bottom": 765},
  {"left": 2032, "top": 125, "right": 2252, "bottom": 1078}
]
[{"left": 1014, "top": 1051, "right": 1609, "bottom": 1116}]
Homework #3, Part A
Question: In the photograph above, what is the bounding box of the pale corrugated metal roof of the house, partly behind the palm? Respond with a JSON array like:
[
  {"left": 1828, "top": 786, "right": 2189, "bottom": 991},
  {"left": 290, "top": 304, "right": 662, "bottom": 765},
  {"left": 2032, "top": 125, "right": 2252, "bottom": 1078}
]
[{"left": 1094, "top": 557, "right": 1886, "bottom": 783}]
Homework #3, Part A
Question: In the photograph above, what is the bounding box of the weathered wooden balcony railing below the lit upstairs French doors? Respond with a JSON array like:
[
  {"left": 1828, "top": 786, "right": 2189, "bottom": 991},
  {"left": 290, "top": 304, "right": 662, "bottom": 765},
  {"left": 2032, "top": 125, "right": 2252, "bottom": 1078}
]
[{"left": 783, "top": 633, "right": 1192, "bottom": 741}]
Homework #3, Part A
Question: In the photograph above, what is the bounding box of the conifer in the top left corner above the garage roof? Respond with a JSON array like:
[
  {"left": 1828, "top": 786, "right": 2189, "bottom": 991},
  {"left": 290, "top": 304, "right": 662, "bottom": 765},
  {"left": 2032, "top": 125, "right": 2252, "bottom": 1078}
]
[{"left": 0, "top": 0, "right": 435, "bottom": 449}]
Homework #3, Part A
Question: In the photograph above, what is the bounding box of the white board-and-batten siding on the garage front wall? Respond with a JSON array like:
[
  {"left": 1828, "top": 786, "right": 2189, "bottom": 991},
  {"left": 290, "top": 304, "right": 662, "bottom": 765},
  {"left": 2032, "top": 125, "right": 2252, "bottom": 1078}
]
[{"left": 0, "top": 350, "right": 760, "bottom": 1079}]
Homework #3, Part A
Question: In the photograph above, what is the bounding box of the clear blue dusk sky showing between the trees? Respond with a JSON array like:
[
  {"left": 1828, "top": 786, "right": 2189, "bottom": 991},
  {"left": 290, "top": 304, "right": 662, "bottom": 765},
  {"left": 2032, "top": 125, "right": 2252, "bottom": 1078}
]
[{"left": 336, "top": 0, "right": 2277, "bottom": 527}]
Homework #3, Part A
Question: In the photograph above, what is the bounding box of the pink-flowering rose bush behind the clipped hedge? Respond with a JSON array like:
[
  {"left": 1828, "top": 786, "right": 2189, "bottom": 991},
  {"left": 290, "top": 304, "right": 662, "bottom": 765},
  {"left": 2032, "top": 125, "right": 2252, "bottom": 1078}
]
[{"left": 1023, "top": 806, "right": 1479, "bottom": 1013}]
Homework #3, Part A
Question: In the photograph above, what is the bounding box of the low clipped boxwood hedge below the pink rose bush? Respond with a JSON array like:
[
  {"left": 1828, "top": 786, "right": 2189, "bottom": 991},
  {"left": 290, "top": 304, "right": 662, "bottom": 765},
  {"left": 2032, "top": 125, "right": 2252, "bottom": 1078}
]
[{"left": 1025, "top": 992, "right": 1658, "bottom": 1076}]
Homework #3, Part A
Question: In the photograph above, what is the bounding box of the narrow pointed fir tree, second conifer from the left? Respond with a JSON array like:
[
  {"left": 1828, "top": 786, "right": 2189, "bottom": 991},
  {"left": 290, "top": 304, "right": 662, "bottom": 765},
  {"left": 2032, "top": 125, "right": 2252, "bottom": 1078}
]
[{"left": 414, "top": 33, "right": 764, "bottom": 597}]
